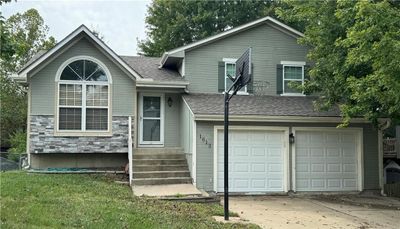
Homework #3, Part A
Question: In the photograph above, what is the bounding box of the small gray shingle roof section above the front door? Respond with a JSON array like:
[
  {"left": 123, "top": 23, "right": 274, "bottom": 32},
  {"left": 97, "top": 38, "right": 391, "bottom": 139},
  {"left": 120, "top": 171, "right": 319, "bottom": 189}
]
[{"left": 120, "top": 56, "right": 185, "bottom": 81}]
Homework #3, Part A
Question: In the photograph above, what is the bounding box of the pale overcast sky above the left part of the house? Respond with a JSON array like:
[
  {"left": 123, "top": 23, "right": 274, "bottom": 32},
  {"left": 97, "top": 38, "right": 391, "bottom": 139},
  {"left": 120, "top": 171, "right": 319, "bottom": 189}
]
[{"left": 1, "top": 0, "right": 150, "bottom": 55}]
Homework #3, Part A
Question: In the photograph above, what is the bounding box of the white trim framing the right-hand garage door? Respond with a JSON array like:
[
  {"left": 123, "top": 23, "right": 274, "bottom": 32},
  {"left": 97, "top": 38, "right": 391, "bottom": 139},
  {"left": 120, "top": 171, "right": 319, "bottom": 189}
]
[{"left": 291, "top": 127, "right": 364, "bottom": 192}]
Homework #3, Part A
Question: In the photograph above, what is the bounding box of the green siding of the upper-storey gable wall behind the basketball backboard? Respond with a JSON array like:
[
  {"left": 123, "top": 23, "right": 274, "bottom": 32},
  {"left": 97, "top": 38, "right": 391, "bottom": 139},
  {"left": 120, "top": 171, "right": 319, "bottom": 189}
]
[{"left": 185, "top": 24, "right": 307, "bottom": 95}]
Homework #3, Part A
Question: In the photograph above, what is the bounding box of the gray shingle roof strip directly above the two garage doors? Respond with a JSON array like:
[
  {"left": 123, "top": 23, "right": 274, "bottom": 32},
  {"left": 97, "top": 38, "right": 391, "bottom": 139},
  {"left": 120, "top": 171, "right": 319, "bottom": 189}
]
[{"left": 184, "top": 94, "right": 340, "bottom": 117}]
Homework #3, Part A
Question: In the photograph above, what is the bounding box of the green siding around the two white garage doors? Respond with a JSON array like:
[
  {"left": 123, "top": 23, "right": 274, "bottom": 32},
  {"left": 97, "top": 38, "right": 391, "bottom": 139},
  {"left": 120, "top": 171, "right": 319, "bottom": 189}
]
[{"left": 196, "top": 121, "right": 379, "bottom": 191}]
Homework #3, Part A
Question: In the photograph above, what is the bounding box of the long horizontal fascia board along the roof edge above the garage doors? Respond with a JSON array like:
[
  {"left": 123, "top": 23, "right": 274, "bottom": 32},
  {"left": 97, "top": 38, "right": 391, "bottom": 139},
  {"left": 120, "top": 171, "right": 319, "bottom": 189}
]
[{"left": 194, "top": 114, "right": 370, "bottom": 123}]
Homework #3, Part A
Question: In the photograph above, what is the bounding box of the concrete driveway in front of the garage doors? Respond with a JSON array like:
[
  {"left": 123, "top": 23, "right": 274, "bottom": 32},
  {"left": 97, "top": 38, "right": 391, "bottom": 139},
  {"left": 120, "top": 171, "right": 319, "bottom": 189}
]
[{"left": 229, "top": 196, "right": 400, "bottom": 229}]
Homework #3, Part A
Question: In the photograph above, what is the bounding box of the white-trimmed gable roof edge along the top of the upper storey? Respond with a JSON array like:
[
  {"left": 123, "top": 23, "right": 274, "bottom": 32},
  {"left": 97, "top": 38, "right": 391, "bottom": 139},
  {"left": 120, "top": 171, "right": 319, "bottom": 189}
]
[{"left": 160, "top": 16, "right": 304, "bottom": 67}]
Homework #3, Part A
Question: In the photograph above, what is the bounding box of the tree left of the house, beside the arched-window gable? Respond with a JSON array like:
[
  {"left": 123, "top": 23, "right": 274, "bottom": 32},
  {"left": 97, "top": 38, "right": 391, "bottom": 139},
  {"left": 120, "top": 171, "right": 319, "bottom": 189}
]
[{"left": 0, "top": 9, "right": 55, "bottom": 147}]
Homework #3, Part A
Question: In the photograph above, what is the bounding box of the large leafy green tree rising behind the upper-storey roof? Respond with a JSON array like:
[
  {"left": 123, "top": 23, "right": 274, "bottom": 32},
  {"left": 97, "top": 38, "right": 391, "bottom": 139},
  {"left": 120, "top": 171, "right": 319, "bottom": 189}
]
[{"left": 138, "top": 0, "right": 278, "bottom": 56}]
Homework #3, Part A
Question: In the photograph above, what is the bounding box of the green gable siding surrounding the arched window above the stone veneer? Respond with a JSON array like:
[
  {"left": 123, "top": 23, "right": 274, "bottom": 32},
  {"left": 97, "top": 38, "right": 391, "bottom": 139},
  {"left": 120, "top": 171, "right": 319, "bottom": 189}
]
[{"left": 30, "top": 38, "right": 136, "bottom": 116}]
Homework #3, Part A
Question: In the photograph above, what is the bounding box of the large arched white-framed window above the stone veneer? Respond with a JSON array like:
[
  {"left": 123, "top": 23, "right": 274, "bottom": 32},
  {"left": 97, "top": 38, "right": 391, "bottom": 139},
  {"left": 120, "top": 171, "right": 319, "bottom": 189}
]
[{"left": 57, "top": 58, "right": 111, "bottom": 132}]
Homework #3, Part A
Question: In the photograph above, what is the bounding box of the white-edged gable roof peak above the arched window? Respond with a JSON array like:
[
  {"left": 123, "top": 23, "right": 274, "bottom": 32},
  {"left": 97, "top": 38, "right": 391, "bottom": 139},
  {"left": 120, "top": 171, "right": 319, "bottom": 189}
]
[{"left": 18, "top": 25, "right": 142, "bottom": 80}]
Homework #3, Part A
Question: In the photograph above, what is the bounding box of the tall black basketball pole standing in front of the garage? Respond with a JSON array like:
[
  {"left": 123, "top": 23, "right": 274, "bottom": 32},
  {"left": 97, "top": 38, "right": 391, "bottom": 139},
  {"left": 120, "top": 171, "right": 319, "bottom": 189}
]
[{"left": 224, "top": 90, "right": 229, "bottom": 220}]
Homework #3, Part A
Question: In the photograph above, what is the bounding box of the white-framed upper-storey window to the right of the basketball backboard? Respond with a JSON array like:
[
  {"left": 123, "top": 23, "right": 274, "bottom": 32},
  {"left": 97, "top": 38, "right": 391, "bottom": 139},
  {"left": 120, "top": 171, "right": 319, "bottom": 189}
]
[{"left": 281, "top": 61, "right": 305, "bottom": 95}]
